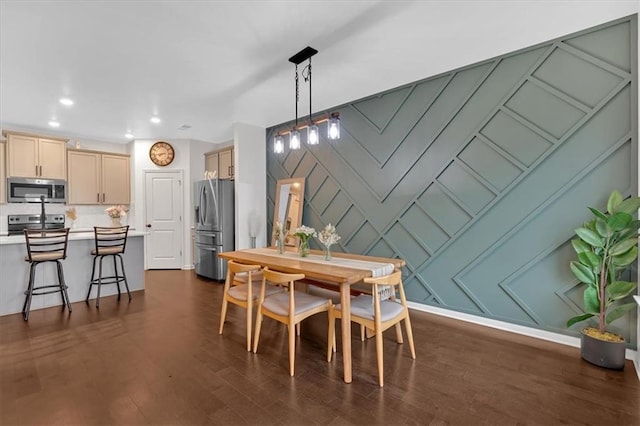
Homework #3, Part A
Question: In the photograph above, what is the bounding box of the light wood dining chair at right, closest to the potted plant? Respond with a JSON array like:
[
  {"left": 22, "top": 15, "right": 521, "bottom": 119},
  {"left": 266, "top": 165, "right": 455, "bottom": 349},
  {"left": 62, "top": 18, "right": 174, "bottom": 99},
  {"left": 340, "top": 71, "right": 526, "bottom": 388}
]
[{"left": 327, "top": 271, "right": 416, "bottom": 387}]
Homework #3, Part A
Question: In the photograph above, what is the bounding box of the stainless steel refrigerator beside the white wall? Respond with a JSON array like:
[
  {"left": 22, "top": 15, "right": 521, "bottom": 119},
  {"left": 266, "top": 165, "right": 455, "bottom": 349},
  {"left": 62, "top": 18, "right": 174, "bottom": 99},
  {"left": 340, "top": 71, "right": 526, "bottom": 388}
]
[{"left": 193, "top": 179, "right": 235, "bottom": 281}]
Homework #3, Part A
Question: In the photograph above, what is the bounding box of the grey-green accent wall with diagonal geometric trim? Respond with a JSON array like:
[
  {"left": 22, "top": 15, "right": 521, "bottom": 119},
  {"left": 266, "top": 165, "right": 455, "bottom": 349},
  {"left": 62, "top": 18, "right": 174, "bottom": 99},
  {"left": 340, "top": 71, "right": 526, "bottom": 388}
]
[{"left": 267, "top": 15, "right": 638, "bottom": 347}]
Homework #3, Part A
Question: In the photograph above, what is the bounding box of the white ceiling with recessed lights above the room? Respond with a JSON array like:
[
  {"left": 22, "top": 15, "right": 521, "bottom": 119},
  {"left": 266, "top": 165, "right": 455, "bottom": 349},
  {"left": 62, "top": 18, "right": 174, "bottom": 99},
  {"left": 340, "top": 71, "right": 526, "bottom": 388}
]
[{"left": 0, "top": 0, "right": 639, "bottom": 143}]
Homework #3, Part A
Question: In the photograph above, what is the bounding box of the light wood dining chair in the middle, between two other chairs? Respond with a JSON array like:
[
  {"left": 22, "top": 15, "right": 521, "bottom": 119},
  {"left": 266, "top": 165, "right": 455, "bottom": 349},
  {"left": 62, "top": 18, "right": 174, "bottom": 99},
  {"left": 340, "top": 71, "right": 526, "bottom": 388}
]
[{"left": 253, "top": 268, "right": 332, "bottom": 376}]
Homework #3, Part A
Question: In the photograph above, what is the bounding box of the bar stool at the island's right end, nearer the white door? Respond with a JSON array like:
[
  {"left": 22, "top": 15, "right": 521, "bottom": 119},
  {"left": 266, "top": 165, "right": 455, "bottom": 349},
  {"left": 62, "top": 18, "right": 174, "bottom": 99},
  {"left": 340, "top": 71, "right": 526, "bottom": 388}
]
[{"left": 85, "top": 225, "right": 131, "bottom": 308}]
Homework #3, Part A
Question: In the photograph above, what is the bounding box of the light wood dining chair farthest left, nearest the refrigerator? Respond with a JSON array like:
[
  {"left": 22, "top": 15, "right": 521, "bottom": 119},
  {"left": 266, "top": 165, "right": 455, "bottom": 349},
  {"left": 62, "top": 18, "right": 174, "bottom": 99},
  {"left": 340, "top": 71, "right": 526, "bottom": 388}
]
[{"left": 218, "top": 260, "right": 282, "bottom": 351}]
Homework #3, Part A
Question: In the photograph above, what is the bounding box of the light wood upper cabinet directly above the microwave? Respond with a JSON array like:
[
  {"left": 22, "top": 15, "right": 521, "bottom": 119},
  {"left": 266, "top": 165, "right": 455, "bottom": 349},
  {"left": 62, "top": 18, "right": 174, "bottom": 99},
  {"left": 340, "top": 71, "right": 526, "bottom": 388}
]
[{"left": 5, "top": 132, "right": 67, "bottom": 179}]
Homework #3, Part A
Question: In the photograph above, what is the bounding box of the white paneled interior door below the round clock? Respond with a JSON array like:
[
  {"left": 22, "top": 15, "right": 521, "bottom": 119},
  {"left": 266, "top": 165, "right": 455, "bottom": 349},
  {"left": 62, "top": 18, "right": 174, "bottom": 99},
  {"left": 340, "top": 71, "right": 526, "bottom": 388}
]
[{"left": 144, "top": 170, "right": 183, "bottom": 269}]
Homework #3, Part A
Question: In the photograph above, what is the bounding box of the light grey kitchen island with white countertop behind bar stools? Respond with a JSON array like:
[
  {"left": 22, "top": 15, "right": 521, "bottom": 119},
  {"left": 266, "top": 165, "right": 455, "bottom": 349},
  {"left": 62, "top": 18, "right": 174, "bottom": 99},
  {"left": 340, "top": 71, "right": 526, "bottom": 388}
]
[{"left": 0, "top": 229, "right": 146, "bottom": 315}]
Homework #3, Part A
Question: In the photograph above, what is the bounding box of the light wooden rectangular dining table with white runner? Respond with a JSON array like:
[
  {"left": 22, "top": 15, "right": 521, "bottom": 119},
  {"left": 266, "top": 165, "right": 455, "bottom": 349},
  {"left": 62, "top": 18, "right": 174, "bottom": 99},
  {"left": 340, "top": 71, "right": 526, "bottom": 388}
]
[{"left": 218, "top": 247, "right": 406, "bottom": 383}]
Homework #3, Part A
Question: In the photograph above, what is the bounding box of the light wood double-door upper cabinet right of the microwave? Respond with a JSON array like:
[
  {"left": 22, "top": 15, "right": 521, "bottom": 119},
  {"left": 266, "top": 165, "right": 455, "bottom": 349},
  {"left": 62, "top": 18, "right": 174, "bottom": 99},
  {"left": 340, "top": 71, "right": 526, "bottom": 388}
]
[{"left": 67, "top": 149, "right": 131, "bottom": 204}]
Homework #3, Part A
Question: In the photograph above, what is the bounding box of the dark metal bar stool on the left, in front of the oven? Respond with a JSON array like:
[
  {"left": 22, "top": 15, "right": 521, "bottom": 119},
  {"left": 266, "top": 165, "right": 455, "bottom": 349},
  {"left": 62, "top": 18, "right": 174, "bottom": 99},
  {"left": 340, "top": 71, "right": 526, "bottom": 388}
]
[{"left": 22, "top": 228, "right": 71, "bottom": 321}]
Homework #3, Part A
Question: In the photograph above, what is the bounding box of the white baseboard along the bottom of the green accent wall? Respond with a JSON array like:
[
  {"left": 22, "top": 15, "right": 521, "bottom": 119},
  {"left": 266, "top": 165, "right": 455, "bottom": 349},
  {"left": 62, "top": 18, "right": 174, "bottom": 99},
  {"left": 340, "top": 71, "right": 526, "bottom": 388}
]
[{"left": 407, "top": 302, "right": 640, "bottom": 380}]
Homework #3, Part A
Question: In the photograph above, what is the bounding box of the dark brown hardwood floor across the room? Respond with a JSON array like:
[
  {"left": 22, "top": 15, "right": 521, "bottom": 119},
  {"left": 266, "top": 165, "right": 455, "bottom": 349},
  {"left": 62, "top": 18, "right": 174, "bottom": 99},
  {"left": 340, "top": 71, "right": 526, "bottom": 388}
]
[{"left": 0, "top": 271, "right": 640, "bottom": 425}]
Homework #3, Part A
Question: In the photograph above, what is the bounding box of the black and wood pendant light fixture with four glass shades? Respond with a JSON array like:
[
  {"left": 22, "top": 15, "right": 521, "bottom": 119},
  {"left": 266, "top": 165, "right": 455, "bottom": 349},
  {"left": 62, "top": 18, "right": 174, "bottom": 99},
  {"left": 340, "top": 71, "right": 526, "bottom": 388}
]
[{"left": 273, "top": 46, "right": 340, "bottom": 154}]
